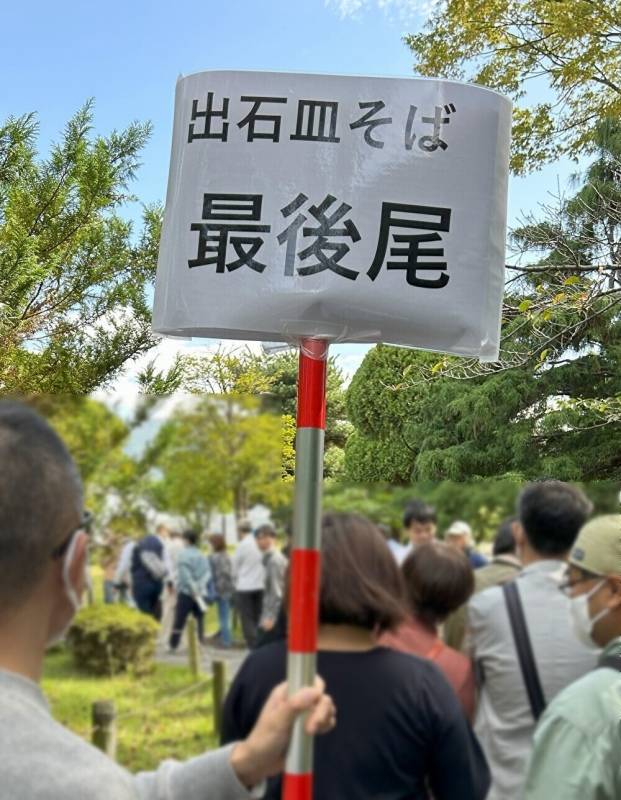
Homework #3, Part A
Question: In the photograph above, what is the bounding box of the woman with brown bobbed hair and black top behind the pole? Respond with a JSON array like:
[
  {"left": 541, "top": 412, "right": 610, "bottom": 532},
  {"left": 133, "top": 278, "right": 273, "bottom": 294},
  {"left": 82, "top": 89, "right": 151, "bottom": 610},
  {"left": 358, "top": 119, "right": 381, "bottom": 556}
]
[{"left": 222, "top": 514, "right": 490, "bottom": 800}]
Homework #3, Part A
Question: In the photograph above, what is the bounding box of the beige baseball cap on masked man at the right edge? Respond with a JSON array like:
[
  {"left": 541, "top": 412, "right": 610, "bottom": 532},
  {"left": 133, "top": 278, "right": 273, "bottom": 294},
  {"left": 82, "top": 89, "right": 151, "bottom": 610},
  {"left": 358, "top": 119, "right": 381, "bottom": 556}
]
[{"left": 569, "top": 514, "right": 621, "bottom": 575}]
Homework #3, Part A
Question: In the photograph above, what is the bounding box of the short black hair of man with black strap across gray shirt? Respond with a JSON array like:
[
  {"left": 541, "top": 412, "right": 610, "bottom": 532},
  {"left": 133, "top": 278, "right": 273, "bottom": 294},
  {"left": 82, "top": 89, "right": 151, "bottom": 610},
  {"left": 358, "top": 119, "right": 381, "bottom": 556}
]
[{"left": 517, "top": 480, "right": 593, "bottom": 557}]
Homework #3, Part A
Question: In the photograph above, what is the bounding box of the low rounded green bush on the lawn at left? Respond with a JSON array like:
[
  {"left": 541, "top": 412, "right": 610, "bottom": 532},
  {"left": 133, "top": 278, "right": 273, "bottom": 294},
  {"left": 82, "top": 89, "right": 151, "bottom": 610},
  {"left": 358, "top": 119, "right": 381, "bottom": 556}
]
[{"left": 67, "top": 604, "right": 159, "bottom": 675}]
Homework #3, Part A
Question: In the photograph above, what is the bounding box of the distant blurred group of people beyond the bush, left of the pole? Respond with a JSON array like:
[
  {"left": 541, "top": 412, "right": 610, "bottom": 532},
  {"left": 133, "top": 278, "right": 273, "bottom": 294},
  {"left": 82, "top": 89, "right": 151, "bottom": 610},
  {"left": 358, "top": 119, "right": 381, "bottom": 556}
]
[{"left": 103, "top": 520, "right": 288, "bottom": 652}]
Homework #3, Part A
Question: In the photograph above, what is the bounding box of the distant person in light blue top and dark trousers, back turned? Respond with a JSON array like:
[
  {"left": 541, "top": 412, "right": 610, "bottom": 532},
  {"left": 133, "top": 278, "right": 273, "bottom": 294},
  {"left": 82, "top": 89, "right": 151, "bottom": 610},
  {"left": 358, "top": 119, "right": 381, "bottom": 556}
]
[{"left": 169, "top": 530, "right": 211, "bottom": 651}]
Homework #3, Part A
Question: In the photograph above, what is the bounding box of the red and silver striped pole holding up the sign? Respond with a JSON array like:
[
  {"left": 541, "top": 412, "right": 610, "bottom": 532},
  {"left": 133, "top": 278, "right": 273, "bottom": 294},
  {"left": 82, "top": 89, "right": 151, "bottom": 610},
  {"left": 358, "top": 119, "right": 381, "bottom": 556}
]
[{"left": 282, "top": 339, "right": 328, "bottom": 800}]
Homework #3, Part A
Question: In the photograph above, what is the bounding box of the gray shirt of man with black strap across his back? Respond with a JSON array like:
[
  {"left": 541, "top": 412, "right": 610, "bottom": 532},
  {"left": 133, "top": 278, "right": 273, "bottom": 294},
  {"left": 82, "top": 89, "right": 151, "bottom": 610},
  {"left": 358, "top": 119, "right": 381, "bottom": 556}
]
[{"left": 468, "top": 560, "right": 597, "bottom": 800}]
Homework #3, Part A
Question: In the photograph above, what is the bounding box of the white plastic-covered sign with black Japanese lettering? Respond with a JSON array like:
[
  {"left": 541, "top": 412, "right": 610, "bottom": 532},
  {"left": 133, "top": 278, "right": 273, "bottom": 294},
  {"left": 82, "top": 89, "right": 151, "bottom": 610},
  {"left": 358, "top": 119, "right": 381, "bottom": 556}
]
[{"left": 153, "top": 72, "right": 511, "bottom": 360}]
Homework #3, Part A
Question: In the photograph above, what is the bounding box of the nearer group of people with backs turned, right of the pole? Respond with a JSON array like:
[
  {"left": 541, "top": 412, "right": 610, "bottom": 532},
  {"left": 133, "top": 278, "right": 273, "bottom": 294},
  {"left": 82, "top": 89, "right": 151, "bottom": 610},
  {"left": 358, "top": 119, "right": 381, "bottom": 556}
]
[{"left": 223, "top": 480, "right": 621, "bottom": 800}]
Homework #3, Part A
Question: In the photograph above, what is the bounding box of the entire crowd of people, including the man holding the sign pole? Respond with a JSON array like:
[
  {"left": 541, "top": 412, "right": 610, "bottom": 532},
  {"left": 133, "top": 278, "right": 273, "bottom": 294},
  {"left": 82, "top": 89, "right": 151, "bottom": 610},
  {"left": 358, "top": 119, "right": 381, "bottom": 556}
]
[{"left": 0, "top": 402, "right": 621, "bottom": 800}]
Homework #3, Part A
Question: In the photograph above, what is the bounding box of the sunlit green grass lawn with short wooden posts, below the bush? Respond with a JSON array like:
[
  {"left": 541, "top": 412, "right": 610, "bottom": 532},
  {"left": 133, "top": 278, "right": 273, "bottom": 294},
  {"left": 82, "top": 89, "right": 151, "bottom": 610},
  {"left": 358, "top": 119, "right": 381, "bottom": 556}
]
[{"left": 43, "top": 649, "right": 217, "bottom": 772}]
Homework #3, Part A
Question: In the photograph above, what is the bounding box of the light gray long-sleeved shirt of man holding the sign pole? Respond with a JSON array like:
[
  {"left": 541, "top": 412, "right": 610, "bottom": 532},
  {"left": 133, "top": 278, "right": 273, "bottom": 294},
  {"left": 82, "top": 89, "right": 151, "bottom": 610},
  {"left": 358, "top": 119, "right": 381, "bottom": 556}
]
[{"left": 0, "top": 670, "right": 256, "bottom": 800}]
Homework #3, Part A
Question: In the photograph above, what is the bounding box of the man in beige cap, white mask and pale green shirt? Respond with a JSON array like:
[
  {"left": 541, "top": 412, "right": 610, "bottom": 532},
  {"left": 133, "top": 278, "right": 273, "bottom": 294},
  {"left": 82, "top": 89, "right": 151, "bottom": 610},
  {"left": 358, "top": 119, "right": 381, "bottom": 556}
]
[{"left": 525, "top": 514, "right": 621, "bottom": 800}]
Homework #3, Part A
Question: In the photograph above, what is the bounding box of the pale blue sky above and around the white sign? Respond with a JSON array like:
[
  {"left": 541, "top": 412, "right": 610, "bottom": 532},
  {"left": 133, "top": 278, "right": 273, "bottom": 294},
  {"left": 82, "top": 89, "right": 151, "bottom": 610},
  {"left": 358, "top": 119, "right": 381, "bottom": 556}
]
[{"left": 0, "top": 0, "right": 575, "bottom": 394}]
